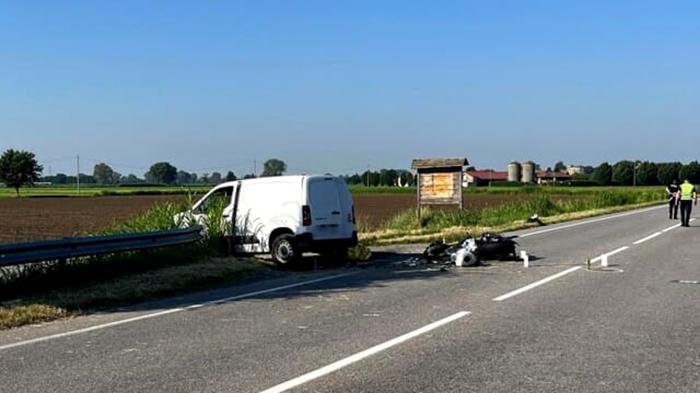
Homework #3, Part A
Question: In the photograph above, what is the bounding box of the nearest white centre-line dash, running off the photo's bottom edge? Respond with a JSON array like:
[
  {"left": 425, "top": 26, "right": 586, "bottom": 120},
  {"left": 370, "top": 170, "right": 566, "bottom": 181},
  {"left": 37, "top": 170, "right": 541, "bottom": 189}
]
[{"left": 260, "top": 311, "right": 471, "bottom": 393}]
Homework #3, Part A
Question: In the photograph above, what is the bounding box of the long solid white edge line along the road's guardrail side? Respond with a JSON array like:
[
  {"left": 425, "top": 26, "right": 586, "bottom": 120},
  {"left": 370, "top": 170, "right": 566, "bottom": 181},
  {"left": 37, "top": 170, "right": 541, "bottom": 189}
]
[{"left": 0, "top": 272, "right": 357, "bottom": 351}]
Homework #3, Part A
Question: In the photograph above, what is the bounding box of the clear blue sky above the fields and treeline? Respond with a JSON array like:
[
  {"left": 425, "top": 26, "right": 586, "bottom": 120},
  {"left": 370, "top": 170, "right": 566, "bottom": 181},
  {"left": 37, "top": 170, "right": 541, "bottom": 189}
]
[{"left": 0, "top": 1, "right": 700, "bottom": 175}]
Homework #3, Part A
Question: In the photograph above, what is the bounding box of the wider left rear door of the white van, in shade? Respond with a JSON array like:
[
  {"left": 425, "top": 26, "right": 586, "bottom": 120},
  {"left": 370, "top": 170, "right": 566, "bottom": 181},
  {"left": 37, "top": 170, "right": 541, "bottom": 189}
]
[{"left": 308, "top": 177, "right": 342, "bottom": 239}]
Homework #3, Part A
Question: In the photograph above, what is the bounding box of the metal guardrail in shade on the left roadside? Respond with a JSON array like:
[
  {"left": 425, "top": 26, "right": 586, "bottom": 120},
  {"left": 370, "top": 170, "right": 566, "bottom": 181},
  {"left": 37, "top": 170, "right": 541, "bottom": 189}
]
[{"left": 0, "top": 226, "right": 202, "bottom": 267}]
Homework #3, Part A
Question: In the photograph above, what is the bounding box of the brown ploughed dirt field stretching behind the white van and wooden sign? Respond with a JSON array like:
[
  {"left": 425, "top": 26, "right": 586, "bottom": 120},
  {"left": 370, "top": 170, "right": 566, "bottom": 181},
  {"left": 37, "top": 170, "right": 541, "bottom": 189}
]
[{"left": 0, "top": 194, "right": 528, "bottom": 243}]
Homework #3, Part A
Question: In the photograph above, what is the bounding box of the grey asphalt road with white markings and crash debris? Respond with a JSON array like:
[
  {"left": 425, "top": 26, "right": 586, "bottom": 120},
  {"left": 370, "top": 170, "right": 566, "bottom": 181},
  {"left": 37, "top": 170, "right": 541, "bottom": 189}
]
[{"left": 0, "top": 204, "right": 700, "bottom": 392}]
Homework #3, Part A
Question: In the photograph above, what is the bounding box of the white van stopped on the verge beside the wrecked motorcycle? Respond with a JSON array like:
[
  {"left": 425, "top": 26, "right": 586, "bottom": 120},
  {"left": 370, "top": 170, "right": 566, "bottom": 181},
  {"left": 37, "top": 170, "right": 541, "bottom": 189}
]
[{"left": 182, "top": 175, "right": 357, "bottom": 264}]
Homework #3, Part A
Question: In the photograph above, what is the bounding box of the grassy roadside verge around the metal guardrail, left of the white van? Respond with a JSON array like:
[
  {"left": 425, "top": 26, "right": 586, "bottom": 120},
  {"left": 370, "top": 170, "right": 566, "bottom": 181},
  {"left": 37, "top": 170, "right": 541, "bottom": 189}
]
[{"left": 0, "top": 194, "right": 245, "bottom": 328}]
